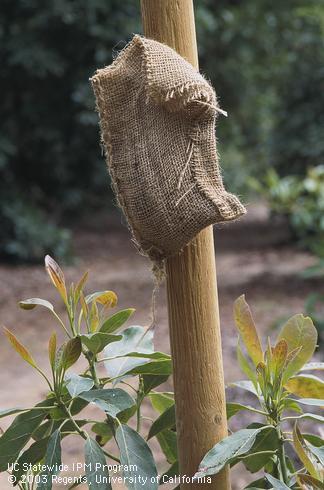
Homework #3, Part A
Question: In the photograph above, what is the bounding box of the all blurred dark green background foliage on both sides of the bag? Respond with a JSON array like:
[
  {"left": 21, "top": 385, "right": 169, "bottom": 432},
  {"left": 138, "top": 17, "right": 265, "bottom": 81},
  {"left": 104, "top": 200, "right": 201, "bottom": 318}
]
[{"left": 0, "top": 0, "right": 324, "bottom": 260}]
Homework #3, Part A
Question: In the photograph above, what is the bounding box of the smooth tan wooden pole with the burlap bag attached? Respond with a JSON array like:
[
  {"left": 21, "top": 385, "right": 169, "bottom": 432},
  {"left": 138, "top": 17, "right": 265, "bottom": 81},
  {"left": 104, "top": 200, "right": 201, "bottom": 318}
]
[{"left": 141, "top": 0, "right": 230, "bottom": 490}]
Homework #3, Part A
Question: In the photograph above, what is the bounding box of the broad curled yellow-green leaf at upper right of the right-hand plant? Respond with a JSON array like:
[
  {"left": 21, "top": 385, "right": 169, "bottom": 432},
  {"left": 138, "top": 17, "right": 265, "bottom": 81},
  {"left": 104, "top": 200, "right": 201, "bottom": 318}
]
[{"left": 278, "top": 314, "right": 317, "bottom": 383}]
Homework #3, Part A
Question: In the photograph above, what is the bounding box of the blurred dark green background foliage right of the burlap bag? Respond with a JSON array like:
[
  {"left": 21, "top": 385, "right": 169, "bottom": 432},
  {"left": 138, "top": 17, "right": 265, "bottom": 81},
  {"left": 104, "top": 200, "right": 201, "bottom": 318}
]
[{"left": 197, "top": 0, "right": 324, "bottom": 189}]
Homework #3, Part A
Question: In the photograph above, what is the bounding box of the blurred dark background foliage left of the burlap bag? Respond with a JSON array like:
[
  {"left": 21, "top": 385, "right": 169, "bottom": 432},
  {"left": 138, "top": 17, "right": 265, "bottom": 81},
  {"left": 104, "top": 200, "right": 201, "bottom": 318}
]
[{"left": 0, "top": 0, "right": 140, "bottom": 261}]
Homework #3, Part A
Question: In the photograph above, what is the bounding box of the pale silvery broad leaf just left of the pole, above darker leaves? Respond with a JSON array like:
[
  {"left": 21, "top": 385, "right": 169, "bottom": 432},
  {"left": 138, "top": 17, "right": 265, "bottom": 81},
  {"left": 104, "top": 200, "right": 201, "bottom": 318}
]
[{"left": 104, "top": 326, "right": 154, "bottom": 379}]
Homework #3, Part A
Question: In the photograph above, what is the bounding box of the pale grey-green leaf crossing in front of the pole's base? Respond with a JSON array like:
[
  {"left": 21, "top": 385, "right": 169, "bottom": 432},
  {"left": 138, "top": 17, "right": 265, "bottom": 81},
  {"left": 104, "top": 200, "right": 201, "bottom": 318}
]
[{"left": 194, "top": 425, "right": 269, "bottom": 480}]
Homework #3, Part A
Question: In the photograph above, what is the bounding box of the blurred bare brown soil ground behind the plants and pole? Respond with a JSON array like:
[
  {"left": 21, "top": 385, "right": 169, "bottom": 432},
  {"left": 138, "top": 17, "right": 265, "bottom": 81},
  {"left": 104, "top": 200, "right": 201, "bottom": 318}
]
[{"left": 0, "top": 205, "right": 324, "bottom": 490}]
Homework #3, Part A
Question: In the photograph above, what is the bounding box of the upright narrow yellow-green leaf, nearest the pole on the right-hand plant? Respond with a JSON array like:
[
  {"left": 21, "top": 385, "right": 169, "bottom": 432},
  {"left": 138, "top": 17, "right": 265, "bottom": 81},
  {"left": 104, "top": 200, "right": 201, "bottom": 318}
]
[{"left": 234, "top": 294, "right": 263, "bottom": 366}]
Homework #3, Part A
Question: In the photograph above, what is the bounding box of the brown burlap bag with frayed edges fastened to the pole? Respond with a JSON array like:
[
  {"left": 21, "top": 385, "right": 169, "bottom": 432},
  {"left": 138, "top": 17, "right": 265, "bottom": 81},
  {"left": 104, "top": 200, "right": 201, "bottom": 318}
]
[{"left": 91, "top": 35, "right": 245, "bottom": 262}]
